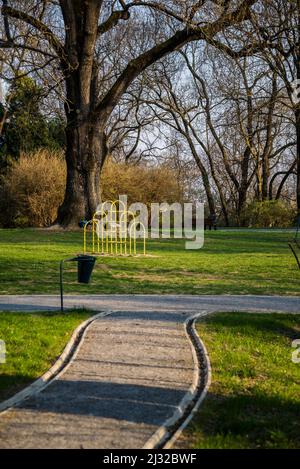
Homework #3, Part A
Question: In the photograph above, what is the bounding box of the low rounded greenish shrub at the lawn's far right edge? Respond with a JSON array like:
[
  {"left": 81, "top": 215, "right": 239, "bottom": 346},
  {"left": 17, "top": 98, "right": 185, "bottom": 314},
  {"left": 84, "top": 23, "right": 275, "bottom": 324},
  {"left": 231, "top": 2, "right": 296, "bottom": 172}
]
[{"left": 243, "top": 200, "right": 296, "bottom": 228}]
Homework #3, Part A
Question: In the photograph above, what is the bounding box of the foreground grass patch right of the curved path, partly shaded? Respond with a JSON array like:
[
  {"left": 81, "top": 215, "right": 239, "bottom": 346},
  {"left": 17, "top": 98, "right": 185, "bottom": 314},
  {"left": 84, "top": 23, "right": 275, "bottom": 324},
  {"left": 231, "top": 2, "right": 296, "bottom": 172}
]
[{"left": 178, "top": 313, "right": 300, "bottom": 449}]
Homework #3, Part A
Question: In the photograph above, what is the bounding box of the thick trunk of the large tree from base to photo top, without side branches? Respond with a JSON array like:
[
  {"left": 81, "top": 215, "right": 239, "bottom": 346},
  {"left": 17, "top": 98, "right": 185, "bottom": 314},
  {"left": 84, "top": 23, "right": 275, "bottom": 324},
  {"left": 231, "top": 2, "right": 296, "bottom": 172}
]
[{"left": 56, "top": 0, "right": 106, "bottom": 228}]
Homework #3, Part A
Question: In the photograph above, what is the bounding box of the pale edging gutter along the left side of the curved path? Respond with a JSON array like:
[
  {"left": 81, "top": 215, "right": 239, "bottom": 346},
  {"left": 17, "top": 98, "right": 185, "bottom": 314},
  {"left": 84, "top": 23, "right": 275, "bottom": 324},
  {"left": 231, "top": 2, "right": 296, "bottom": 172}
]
[{"left": 0, "top": 311, "right": 113, "bottom": 416}]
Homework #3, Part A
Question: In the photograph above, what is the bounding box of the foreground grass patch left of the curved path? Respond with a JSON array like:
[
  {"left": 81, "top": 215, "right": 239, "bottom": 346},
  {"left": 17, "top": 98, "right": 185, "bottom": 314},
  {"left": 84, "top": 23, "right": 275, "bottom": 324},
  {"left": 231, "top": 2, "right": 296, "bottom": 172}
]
[{"left": 0, "top": 311, "right": 91, "bottom": 401}]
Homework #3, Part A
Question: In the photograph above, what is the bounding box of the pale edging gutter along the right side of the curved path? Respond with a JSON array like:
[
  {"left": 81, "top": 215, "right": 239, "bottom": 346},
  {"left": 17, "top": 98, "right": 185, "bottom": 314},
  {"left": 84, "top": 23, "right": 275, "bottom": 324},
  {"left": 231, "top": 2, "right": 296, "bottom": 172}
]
[{"left": 143, "top": 311, "right": 211, "bottom": 449}]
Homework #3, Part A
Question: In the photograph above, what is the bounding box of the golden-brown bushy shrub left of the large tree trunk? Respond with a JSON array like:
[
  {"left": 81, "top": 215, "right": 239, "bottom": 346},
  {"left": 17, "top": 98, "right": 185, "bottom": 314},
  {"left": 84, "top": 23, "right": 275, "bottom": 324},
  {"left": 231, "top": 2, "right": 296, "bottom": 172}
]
[{"left": 0, "top": 150, "right": 66, "bottom": 227}]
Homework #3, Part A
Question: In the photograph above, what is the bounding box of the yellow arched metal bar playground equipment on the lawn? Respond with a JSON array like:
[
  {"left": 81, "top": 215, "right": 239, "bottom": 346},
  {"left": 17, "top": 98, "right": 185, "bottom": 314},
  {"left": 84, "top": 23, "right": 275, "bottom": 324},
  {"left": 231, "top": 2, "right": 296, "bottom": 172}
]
[{"left": 83, "top": 200, "right": 146, "bottom": 256}]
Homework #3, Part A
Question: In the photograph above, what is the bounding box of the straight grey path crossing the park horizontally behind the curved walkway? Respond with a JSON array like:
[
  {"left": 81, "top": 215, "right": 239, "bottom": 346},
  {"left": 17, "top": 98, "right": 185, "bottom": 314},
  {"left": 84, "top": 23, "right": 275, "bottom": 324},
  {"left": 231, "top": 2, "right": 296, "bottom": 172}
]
[{"left": 0, "top": 295, "right": 300, "bottom": 313}]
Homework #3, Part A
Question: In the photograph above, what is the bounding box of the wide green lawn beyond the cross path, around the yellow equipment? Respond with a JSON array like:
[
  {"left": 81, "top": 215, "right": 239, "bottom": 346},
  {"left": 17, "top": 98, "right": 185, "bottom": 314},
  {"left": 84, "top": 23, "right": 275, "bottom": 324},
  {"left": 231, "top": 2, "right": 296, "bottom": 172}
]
[{"left": 0, "top": 229, "right": 300, "bottom": 295}]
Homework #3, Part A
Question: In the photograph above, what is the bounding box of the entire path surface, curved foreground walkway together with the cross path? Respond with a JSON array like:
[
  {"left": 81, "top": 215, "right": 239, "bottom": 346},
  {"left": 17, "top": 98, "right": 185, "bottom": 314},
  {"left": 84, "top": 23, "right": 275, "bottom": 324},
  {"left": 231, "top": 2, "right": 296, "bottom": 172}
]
[{"left": 0, "top": 295, "right": 300, "bottom": 449}]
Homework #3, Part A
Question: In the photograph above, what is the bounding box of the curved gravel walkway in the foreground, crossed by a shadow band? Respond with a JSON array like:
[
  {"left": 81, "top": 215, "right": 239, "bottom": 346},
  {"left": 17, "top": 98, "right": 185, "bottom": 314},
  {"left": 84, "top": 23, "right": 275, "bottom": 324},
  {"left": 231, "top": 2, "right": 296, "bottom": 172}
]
[{"left": 0, "top": 312, "right": 194, "bottom": 448}]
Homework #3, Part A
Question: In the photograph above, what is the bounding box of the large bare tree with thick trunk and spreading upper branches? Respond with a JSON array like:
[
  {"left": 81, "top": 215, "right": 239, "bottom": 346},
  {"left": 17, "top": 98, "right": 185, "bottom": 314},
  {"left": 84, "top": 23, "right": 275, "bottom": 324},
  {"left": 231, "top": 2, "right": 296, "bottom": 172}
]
[{"left": 0, "top": 0, "right": 257, "bottom": 227}]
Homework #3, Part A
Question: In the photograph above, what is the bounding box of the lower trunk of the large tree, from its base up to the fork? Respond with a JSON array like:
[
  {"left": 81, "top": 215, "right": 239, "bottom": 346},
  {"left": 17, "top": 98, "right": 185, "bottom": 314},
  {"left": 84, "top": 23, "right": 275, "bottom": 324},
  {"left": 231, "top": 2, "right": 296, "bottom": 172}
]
[{"left": 56, "top": 119, "right": 107, "bottom": 228}]
